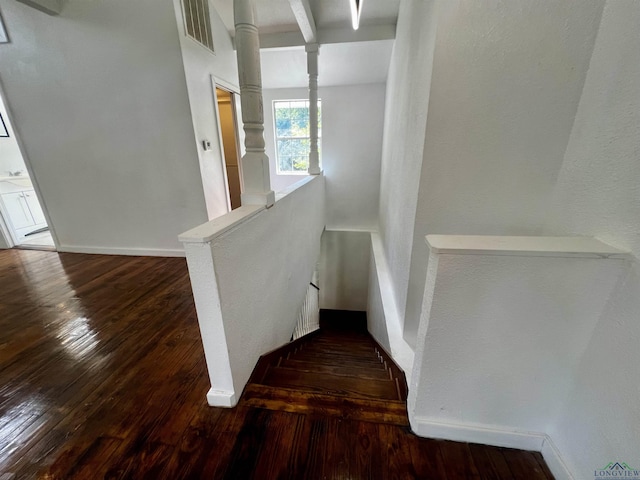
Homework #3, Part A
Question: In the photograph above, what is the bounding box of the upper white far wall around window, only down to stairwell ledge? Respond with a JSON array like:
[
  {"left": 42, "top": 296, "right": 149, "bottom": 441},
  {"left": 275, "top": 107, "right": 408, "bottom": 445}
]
[{"left": 263, "top": 85, "right": 384, "bottom": 230}]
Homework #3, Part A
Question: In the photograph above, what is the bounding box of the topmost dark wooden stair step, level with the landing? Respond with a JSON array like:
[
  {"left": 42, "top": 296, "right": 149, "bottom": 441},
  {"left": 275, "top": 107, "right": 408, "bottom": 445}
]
[{"left": 241, "top": 383, "right": 409, "bottom": 427}]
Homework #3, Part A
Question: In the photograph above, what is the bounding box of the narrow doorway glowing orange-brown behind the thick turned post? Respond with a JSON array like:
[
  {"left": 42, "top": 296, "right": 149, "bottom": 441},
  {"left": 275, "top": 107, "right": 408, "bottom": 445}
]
[{"left": 215, "top": 84, "right": 242, "bottom": 210}]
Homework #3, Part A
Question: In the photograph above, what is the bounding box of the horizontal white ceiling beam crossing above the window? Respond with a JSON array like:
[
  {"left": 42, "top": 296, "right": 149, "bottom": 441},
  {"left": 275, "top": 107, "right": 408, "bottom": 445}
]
[{"left": 260, "top": 24, "right": 396, "bottom": 49}]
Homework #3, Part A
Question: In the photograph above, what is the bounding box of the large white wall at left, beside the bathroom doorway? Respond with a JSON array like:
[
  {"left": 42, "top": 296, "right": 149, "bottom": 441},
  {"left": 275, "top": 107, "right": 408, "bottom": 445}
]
[{"left": 0, "top": 0, "right": 207, "bottom": 254}]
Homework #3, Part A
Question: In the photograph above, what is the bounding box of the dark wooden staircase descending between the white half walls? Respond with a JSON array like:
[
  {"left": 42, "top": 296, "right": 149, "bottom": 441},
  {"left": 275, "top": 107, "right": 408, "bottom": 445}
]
[{"left": 241, "top": 310, "right": 408, "bottom": 426}]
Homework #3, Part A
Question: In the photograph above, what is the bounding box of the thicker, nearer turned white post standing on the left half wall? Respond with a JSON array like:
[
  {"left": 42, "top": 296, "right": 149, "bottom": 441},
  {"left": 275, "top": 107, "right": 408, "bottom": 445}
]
[{"left": 233, "top": 0, "right": 275, "bottom": 207}]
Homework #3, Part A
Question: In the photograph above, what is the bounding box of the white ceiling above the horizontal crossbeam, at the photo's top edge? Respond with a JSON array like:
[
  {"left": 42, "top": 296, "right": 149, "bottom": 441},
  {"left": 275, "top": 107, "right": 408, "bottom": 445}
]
[{"left": 211, "top": 0, "right": 400, "bottom": 36}]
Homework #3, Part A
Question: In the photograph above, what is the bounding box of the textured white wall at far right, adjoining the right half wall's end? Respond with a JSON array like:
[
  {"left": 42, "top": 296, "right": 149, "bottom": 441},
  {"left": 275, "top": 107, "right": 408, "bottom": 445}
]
[{"left": 547, "top": 0, "right": 640, "bottom": 479}]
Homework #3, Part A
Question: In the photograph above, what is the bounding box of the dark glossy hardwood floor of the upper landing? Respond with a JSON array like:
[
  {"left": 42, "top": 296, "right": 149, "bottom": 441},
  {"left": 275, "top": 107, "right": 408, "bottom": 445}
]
[{"left": 0, "top": 250, "right": 552, "bottom": 480}]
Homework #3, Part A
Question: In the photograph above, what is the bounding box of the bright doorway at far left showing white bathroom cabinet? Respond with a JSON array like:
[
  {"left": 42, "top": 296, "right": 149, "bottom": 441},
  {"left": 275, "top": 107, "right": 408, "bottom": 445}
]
[{"left": 0, "top": 91, "right": 55, "bottom": 250}]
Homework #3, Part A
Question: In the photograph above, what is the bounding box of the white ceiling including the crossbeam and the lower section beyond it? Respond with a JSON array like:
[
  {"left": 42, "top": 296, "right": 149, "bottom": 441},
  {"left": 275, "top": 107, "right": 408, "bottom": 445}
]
[{"left": 210, "top": 0, "right": 400, "bottom": 89}]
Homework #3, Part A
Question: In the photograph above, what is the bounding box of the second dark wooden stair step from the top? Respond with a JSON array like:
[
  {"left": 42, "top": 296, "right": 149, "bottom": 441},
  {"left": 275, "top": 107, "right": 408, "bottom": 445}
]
[{"left": 262, "top": 367, "right": 400, "bottom": 400}]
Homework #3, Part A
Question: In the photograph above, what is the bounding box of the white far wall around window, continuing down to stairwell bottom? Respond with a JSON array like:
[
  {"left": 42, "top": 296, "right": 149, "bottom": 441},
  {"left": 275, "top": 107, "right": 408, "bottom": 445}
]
[{"left": 264, "top": 84, "right": 385, "bottom": 311}]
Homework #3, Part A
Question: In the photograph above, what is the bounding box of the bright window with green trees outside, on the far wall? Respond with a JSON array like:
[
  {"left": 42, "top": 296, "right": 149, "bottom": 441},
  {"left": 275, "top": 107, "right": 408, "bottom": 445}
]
[{"left": 273, "top": 100, "right": 322, "bottom": 174}]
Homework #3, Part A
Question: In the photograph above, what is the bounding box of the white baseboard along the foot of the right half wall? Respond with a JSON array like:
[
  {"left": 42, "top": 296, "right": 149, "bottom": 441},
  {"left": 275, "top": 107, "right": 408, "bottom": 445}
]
[{"left": 409, "top": 414, "right": 547, "bottom": 452}]
